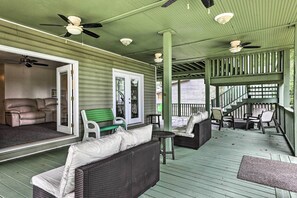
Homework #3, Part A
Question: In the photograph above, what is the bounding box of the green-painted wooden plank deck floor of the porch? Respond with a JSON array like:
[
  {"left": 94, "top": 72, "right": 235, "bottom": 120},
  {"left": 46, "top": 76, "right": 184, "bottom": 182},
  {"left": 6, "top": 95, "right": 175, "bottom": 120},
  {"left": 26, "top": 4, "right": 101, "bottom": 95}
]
[{"left": 0, "top": 128, "right": 297, "bottom": 198}]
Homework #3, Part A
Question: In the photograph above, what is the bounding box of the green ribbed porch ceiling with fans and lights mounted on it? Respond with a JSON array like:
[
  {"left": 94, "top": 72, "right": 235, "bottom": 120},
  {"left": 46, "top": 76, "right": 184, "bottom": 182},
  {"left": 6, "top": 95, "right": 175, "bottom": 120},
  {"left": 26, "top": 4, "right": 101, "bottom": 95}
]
[{"left": 0, "top": 0, "right": 297, "bottom": 76}]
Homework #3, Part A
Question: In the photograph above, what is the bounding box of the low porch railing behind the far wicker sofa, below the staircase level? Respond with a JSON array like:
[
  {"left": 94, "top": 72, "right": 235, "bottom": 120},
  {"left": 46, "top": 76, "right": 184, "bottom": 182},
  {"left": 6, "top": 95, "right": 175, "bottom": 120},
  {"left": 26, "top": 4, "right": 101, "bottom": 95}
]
[{"left": 157, "top": 103, "right": 205, "bottom": 116}]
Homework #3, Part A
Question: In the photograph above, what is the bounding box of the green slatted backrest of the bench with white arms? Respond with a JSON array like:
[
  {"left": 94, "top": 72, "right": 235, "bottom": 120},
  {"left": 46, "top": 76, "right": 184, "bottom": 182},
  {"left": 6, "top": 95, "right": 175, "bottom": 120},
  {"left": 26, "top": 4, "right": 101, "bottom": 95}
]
[{"left": 86, "top": 109, "right": 114, "bottom": 122}]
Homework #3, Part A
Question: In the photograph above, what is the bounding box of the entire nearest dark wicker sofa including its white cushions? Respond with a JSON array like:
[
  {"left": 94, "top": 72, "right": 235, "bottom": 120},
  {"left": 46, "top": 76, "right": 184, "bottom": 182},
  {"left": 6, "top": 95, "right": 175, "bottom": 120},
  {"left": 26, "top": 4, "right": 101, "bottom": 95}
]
[{"left": 31, "top": 125, "right": 160, "bottom": 198}]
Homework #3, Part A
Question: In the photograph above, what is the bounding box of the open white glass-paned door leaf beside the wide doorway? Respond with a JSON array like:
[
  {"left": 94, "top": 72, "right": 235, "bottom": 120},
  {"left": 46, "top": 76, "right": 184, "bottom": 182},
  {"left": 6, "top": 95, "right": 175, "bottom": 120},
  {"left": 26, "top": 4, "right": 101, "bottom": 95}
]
[{"left": 56, "top": 65, "right": 73, "bottom": 134}]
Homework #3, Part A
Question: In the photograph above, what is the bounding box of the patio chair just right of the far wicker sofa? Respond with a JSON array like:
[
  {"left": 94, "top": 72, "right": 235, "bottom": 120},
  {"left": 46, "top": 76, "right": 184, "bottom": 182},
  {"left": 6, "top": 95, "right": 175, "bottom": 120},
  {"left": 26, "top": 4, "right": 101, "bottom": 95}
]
[{"left": 211, "top": 107, "right": 235, "bottom": 130}]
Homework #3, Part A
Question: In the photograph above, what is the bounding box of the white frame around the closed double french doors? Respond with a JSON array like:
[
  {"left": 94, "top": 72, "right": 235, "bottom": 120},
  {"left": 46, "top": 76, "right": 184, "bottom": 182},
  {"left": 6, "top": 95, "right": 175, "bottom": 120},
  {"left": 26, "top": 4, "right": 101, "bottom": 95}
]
[{"left": 112, "top": 69, "right": 144, "bottom": 124}]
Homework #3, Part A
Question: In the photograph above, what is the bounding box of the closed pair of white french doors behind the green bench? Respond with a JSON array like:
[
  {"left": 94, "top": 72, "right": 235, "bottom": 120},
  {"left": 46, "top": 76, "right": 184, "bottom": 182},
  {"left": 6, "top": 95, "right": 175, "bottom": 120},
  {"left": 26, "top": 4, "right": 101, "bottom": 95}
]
[{"left": 113, "top": 70, "right": 143, "bottom": 124}]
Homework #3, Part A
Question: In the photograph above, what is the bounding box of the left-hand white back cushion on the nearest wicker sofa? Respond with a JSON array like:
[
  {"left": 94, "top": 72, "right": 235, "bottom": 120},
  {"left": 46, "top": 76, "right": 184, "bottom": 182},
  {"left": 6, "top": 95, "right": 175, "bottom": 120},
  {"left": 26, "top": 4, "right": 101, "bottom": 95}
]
[{"left": 60, "top": 133, "right": 122, "bottom": 197}]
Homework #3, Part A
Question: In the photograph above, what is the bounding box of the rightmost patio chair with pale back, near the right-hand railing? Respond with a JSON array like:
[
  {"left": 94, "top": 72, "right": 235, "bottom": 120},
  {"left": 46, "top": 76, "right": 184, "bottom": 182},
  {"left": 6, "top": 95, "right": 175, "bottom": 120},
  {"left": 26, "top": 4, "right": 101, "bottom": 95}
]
[{"left": 246, "top": 110, "right": 279, "bottom": 134}]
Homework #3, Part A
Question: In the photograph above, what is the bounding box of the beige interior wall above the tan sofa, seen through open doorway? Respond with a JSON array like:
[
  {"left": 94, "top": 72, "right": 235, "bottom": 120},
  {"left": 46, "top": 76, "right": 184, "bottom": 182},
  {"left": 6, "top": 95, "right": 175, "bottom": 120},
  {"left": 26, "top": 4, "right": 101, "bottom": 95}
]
[{"left": 5, "top": 64, "right": 56, "bottom": 98}]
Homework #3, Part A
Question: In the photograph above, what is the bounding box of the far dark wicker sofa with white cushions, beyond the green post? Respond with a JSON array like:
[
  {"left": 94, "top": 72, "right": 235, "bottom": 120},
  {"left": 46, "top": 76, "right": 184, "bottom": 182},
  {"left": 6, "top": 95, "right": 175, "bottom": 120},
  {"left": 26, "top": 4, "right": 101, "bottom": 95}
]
[{"left": 173, "top": 112, "right": 211, "bottom": 149}]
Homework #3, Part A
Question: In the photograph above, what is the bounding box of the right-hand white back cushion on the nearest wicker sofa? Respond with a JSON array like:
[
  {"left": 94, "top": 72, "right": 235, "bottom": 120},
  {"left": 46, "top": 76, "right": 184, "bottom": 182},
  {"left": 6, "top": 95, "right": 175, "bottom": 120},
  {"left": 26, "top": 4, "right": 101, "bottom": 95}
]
[{"left": 117, "top": 124, "right": 153, "bottom": 151}]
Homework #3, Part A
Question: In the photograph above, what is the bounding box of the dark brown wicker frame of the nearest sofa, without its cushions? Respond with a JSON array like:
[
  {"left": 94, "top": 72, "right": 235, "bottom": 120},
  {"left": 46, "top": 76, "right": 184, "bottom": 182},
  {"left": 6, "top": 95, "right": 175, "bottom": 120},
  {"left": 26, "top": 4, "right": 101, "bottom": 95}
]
[{"left": 33, "top": 141, "right": 160, "bottom": 198}]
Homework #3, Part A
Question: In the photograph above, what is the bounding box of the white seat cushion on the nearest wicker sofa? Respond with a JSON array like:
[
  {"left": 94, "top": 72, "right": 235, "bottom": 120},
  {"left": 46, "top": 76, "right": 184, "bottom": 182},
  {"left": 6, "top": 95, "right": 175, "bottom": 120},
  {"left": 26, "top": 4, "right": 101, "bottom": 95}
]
[{"left": 31, "top": 166, "right": 64, "bottom": 197}]
